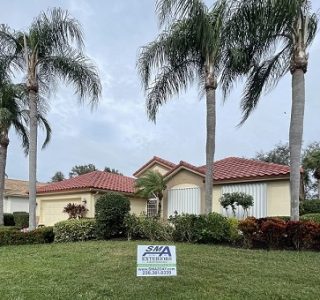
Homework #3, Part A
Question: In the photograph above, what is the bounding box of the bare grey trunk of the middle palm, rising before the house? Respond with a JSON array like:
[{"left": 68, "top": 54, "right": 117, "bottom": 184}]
[{"left": 205, "top": 74, "right": 217, "bottom": 214}]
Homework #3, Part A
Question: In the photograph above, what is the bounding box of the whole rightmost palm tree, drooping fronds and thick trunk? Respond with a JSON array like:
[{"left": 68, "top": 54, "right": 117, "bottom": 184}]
[{"left": 224, "top": 0, "right": 318, "bottom": 220}]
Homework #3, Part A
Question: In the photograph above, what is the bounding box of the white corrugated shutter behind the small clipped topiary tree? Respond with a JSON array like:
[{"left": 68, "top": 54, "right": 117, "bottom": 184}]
[{"left": 222, "top": 183, "right": 267, "bottom": 219}]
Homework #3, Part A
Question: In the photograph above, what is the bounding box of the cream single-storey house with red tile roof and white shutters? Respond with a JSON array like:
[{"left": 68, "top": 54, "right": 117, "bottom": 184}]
[{"left": 37, "top": 156, "right": 290, "bottom": 225}]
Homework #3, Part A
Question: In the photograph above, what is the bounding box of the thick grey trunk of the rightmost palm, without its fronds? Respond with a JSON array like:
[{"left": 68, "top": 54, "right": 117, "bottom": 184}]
[{"left": 289, "top": 68, "right": 305, "bottom": 221}]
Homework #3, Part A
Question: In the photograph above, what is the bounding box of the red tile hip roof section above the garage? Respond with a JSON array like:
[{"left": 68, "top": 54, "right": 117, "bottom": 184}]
[{"left": 37, "top": 171, "right": 135, "bottom": 193}]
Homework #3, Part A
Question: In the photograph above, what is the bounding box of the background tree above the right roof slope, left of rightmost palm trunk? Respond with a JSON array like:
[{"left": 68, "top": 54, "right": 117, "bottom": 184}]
[{"left": 254, "top": 143, "right": 290, "bottom": 166}]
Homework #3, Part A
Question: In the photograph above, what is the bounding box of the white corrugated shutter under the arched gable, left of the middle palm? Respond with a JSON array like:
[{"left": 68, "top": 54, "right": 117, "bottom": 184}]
[{"left": 168, "top": 188, "right": 201, "bottom": 217}]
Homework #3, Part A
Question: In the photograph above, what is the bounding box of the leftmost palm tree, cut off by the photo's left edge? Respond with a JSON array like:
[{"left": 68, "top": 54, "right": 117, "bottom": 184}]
[{"left": 0, "top": 82, "right": 51, "bottom": 225}]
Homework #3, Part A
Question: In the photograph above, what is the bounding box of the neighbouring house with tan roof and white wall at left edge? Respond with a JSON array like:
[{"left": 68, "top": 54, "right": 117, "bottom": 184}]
[{"left": 3, "top": 179, "right": 42, "bottom": 213}]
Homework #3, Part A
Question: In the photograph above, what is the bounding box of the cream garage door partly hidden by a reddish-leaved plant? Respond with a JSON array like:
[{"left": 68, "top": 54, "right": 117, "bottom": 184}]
[{"left": 40, "top": 200, "right": 81, "bottom": 226}]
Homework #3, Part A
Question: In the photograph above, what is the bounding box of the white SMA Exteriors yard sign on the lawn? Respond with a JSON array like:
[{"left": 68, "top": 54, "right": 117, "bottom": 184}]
[{"left": 137, "top": 245, "right": 177, "bottom": 276}]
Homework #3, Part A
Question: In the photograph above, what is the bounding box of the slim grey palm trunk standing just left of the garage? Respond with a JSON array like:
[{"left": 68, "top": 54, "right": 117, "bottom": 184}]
[{"left": 29, "top": 89, "right": 38, "bottom": 230}]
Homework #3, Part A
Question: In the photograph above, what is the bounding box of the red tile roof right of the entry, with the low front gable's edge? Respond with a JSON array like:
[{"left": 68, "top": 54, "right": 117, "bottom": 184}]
[{"left": 166, "top": 157, "right": 290, "bottom": 182}]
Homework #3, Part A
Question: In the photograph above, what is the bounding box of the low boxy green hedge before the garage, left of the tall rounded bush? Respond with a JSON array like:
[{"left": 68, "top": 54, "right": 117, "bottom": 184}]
[{"left": 53, "top": 219, "right": 96, "bottom": 242}]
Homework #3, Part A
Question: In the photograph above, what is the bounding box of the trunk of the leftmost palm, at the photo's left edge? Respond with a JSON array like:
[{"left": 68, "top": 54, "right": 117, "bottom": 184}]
[{"left": 0, "top": 133, "right": 9, "bottom": 226}]
